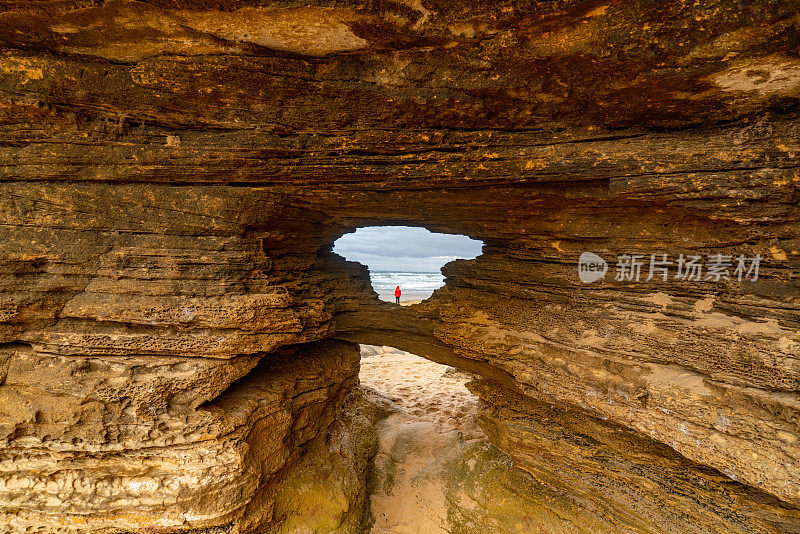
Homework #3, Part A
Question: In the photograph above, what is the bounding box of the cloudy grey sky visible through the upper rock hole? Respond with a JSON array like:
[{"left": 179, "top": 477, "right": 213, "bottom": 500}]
[{"left": 333, "top": 226, "right": 483, "bottom": 272}]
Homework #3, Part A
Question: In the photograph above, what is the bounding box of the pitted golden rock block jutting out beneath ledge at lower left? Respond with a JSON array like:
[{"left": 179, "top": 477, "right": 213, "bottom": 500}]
[{"left": 0, "top": 341, "right": 368, "bottom": 532}]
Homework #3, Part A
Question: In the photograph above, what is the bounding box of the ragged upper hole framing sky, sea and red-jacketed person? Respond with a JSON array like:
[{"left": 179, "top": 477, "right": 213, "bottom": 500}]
[{"left": 333, "top": 226, "right": 483, "bottom": 304}]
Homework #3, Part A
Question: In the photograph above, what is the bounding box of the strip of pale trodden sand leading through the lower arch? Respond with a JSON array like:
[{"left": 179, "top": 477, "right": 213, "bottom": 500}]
[{"left": 360, "top": 346, "right": 486, "bottom": 534}]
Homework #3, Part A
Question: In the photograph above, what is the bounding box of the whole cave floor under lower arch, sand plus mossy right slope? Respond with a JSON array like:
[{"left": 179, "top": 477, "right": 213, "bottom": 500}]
[{"left": 360, "top": 345, "right": 600, "bottom": 534}]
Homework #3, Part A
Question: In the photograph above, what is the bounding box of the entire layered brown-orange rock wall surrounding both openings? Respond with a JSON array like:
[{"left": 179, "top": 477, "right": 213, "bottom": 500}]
[{"left": 0, "top": 0, "right": 800, "bottom": 533}]
